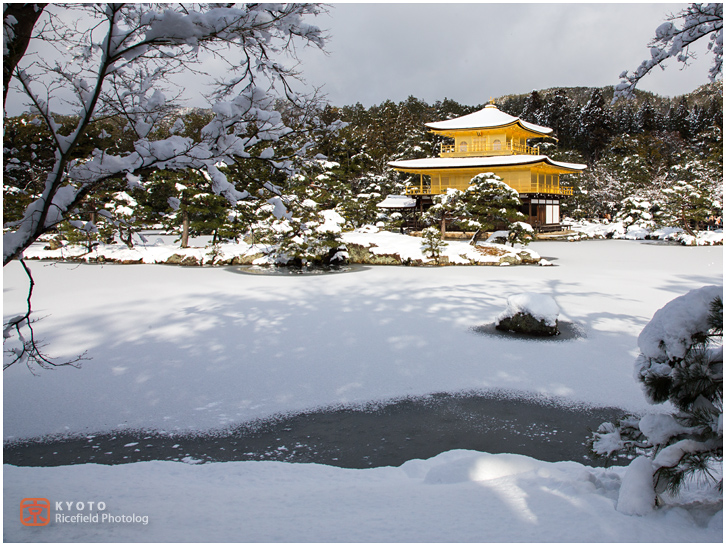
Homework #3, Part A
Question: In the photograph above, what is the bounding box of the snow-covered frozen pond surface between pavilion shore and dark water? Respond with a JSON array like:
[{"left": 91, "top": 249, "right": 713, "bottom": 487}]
[{"left": 3, "top": 241, "right": 723, "bottom": 450}]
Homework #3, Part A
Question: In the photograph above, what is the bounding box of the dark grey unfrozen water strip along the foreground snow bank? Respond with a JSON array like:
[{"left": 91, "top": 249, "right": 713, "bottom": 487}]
[{"left": 3, "top": 394, "right": 627, "bottom": 468}]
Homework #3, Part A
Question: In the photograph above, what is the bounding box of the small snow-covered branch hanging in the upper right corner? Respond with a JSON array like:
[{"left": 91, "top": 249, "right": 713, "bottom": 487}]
[{"left": 613, "top": 3, "right": 723, "bottom": 101}]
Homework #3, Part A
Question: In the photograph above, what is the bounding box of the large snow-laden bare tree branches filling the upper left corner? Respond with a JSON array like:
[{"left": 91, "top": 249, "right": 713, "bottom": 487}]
[{"left": 3, "top": 4, "right": 325, "bottom": 265}]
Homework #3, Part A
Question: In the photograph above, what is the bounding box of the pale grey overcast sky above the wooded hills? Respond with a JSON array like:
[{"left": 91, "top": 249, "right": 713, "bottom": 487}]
[{"left": 7, "top": 2, "right": 724, "bottom": 115}]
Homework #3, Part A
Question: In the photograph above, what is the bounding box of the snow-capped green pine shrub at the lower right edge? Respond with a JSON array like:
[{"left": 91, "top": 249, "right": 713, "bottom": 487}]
[{"left": 590, "top": 286, "right": 723, "bottom": 513}]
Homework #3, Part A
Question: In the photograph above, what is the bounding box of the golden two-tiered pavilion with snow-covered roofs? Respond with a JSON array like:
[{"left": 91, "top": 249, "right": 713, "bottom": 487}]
[{"left": 388, "top": 104, "right": 587, "bottom": 229}]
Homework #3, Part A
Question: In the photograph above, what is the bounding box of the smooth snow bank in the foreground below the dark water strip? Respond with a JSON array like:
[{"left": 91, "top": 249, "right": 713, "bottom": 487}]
[{"left": 3, "top": 450, "right": 723, "bottom": 543}]
